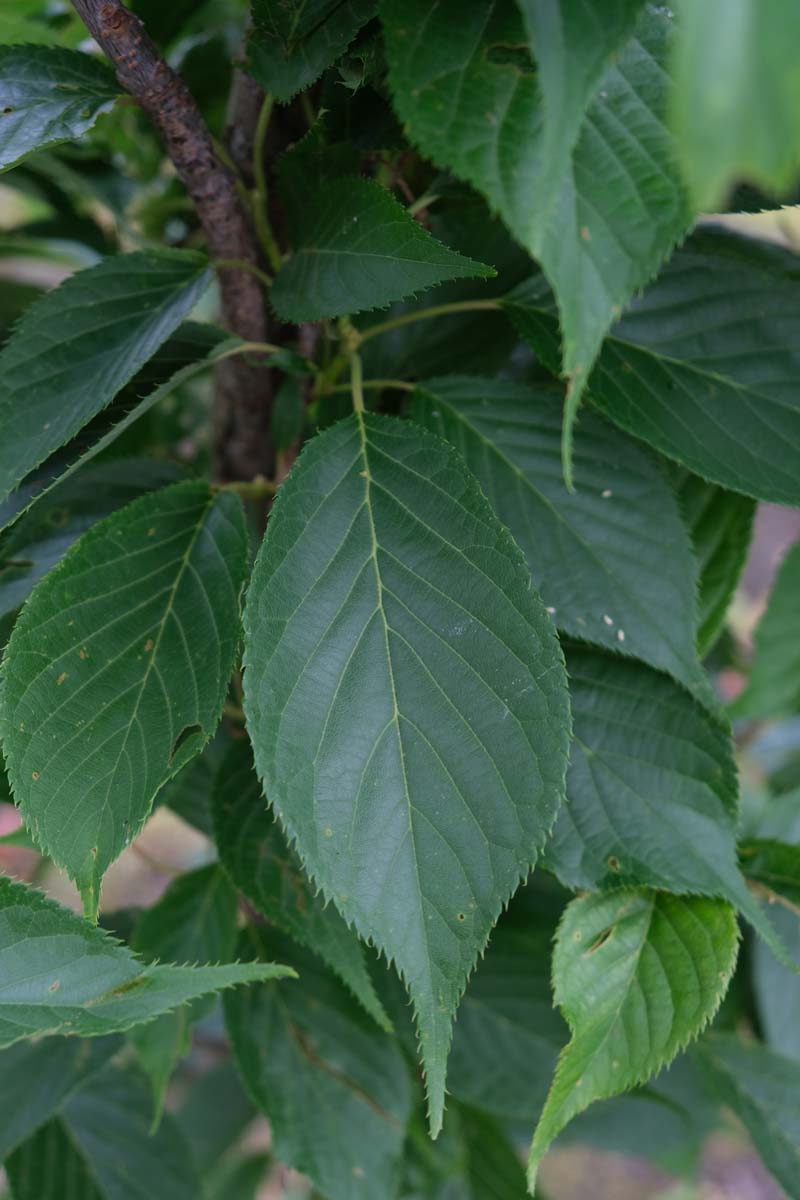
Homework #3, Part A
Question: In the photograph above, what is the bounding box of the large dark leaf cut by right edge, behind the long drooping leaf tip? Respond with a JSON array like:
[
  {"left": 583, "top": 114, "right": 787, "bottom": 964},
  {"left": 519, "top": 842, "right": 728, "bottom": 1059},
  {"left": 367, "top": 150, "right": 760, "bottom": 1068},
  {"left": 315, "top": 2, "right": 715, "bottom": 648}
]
[{"left": 505, "top": 228, "right": 800, "bottom": 505}]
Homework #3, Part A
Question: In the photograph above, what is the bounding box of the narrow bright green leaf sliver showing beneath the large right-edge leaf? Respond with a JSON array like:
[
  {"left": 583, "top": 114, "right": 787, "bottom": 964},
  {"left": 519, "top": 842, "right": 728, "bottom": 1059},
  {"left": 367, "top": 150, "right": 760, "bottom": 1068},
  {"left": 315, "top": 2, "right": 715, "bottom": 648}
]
[{"left": 670, "top": 466, "right": 756, "bottom": 656}]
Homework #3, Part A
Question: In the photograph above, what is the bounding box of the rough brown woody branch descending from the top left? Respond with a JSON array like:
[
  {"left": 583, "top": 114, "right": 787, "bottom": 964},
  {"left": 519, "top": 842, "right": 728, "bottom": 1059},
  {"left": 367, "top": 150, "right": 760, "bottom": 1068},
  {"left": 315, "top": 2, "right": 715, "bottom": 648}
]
[{"left": 72, "top": 0, "right": 272, "bottom": 480}]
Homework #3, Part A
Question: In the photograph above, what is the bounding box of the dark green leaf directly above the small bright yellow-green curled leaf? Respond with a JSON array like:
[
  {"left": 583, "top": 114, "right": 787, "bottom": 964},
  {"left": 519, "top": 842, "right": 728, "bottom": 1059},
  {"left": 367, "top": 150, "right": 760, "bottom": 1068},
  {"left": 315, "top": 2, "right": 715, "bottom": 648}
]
[{"left": 545, "top": 647, "right": 786, "bottom": 958}]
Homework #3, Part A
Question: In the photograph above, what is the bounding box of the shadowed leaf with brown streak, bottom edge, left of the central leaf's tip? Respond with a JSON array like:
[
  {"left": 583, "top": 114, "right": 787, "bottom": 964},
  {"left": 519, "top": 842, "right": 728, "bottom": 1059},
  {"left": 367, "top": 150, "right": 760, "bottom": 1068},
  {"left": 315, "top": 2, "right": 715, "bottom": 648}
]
[{"left": 224, "top": 935, "right": 411, "bottom": 1200}]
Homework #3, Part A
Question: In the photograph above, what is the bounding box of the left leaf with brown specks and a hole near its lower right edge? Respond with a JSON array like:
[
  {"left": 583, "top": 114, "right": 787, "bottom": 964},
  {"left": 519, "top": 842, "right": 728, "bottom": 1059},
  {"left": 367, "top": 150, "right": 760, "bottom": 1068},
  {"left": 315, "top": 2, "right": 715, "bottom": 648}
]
[{"left": 0, "top": 482, "right": 248, "bottom": 917}]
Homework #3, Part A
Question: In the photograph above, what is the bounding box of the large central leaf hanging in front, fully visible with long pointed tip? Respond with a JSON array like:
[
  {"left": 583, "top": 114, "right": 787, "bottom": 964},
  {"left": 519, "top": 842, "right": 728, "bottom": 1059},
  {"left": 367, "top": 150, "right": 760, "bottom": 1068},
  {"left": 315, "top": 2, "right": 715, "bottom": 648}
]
[{"left": 245, "top": 414, "right": 569, "bottom": 1132}]
